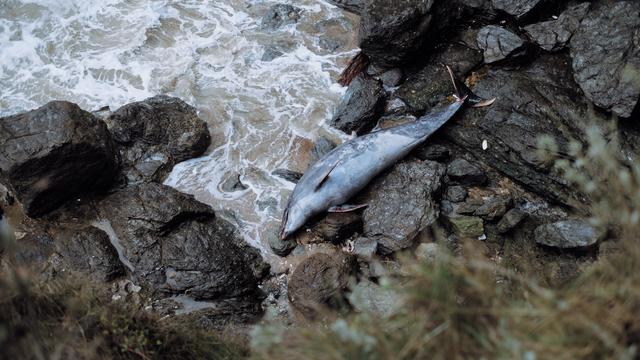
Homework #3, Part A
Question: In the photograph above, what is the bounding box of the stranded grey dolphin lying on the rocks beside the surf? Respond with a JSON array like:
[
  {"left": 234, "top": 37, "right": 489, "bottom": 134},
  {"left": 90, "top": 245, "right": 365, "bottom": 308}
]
[{"left": 280, "top": 67, "right": 495, "bottom": 239}]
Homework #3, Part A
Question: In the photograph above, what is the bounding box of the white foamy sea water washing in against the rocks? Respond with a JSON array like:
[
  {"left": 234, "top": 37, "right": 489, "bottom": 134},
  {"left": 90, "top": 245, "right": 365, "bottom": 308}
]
[{"left": 0, "top": 0, "right": 355, "bottom": 264}]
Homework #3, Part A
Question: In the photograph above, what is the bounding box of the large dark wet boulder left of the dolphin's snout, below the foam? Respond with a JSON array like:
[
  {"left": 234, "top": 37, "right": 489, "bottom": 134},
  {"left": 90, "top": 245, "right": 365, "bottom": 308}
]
[{"left": 97, "top": 183, "right": 266, "bottom": 300}]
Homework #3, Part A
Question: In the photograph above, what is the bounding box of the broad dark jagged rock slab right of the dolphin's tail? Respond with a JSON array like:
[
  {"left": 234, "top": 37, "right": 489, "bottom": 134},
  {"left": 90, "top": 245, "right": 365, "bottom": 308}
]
[{"left": 441, "top": 55, "right": 596, "bottom": 208}]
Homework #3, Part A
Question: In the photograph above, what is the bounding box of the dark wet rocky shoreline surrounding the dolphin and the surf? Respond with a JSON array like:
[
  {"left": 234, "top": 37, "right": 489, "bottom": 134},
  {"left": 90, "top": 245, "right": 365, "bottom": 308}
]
[{"left": 0, "top": 0, "right": 640, "bottom": 334}]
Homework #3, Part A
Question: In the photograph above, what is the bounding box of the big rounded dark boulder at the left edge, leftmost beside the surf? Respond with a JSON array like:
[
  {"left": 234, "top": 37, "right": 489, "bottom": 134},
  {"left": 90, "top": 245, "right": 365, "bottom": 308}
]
[{"left": 0, "top": 101, "right": 119, "bottom": 217}]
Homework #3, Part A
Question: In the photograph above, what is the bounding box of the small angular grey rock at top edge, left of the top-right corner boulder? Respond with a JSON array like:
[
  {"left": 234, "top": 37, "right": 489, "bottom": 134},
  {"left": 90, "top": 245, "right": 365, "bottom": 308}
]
[{"left": 524, "top": 3, "right": 589, "bottom": 51}]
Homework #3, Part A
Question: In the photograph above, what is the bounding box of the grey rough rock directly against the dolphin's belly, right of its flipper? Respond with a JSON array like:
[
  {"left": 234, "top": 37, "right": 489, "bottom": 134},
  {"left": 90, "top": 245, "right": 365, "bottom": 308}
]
[{"left": 363, "top": 161, "right": 445, "bottom": 254}]
